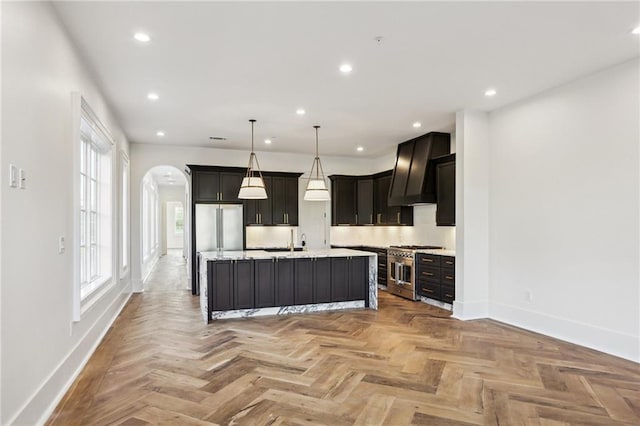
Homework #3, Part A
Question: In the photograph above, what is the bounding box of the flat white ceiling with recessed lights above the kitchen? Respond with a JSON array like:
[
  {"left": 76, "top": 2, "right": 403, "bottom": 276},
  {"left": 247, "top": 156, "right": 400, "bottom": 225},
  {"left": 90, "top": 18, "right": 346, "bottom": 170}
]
[{"left": 55, "top": 2, "right": 640, "bottom": 157}]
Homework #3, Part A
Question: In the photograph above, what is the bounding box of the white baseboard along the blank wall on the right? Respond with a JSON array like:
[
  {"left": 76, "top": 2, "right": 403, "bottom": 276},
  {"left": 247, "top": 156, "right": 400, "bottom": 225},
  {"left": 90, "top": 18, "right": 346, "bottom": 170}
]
[{"left": 490, "top": 303, "right": 640, "bottom": 362}]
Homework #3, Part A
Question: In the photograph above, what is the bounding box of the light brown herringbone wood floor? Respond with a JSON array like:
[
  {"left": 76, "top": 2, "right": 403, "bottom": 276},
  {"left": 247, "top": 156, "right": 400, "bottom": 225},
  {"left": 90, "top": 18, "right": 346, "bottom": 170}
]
[{"left": 48, "top": 251, "right": 640, "bottom": 426}]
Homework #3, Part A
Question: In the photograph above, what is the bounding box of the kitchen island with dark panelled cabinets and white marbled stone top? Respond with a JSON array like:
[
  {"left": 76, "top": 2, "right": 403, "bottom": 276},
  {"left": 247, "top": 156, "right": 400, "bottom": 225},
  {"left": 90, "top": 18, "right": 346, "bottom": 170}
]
[{"left": 197, "top": 249, "right": 378, "bottom": 323}]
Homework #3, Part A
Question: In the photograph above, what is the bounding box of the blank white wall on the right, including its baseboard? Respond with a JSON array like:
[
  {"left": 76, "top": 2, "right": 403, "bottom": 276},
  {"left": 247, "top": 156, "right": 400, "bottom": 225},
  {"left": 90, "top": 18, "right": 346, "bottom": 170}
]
[{"left": 488, "top": 60, "right": 640, "bottom": 361}]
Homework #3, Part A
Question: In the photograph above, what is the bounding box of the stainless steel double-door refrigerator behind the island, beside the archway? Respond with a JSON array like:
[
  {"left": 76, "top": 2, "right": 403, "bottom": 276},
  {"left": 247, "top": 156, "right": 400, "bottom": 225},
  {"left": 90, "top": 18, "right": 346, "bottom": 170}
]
[{"left": 192, "top": 204, "right": 244, "bottom": 294}]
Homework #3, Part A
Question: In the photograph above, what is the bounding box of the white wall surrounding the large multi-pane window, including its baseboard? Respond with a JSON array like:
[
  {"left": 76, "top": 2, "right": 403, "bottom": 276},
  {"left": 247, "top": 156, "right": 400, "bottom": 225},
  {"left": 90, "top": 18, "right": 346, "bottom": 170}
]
[{"left": 0, "top": 2, "right": 130, "bottom": 424}]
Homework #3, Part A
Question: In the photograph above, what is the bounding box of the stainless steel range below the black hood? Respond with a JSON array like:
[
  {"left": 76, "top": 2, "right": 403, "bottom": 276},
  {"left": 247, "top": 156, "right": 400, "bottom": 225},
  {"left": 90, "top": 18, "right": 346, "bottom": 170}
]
[{"left": 387, "top": 246, "right": 442, "bottom": 300}]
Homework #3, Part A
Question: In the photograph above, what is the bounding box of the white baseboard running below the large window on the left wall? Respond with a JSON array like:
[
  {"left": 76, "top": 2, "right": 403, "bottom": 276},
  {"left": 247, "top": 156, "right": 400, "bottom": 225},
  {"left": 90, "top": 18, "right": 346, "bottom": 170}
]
[{"left": 7, "top": 283, "right": 131, "bottom": 425}]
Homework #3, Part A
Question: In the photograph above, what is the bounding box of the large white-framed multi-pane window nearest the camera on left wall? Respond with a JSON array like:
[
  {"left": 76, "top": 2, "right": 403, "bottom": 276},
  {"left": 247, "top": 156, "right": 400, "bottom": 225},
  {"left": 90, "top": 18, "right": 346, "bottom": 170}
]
[{"left": 75, "top": 95, "right": 113, "bottom": 319}]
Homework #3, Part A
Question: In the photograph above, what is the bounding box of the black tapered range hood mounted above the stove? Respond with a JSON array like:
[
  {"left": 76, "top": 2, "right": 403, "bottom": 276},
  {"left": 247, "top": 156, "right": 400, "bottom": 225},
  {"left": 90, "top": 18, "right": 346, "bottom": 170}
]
[{"left": 389, "top": 132, "right": 451, "bottom": 206}]
